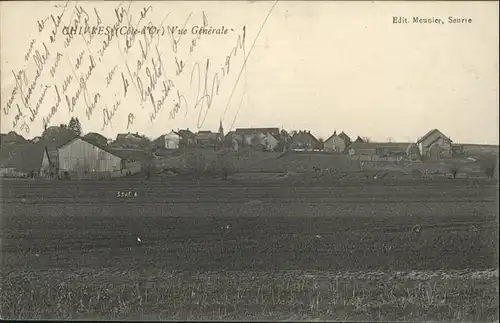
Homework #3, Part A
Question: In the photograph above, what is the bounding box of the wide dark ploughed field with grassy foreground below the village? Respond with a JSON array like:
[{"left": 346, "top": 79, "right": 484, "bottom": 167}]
[{"left": 0, "top": 179, "right": 498, "bottom": 322}]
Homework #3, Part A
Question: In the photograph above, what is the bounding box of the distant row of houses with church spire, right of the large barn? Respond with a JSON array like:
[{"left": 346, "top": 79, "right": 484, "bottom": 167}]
[{"left": 152, "top": 125, "right": 457, "bottom": 161}]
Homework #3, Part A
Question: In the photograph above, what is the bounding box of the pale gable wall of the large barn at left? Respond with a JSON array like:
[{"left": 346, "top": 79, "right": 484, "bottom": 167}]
[{"left": 59, "top": 138, "right": 121, "bottom": 172}]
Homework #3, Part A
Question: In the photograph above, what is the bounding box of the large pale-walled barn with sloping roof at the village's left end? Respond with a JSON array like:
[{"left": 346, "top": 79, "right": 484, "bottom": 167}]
[{"left": 40, "top": 137, "right": 124, "bottom": 178}]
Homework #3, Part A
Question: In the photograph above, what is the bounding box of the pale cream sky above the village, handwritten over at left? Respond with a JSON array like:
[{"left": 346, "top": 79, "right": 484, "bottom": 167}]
[{"left": 0, "top": 1, "right": 499, "bottom": 144}]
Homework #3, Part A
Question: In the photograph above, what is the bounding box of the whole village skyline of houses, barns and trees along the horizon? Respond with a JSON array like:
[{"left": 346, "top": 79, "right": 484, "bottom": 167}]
[{"left": 0, "top": 118, "right": 498, "bottom": 179}]
